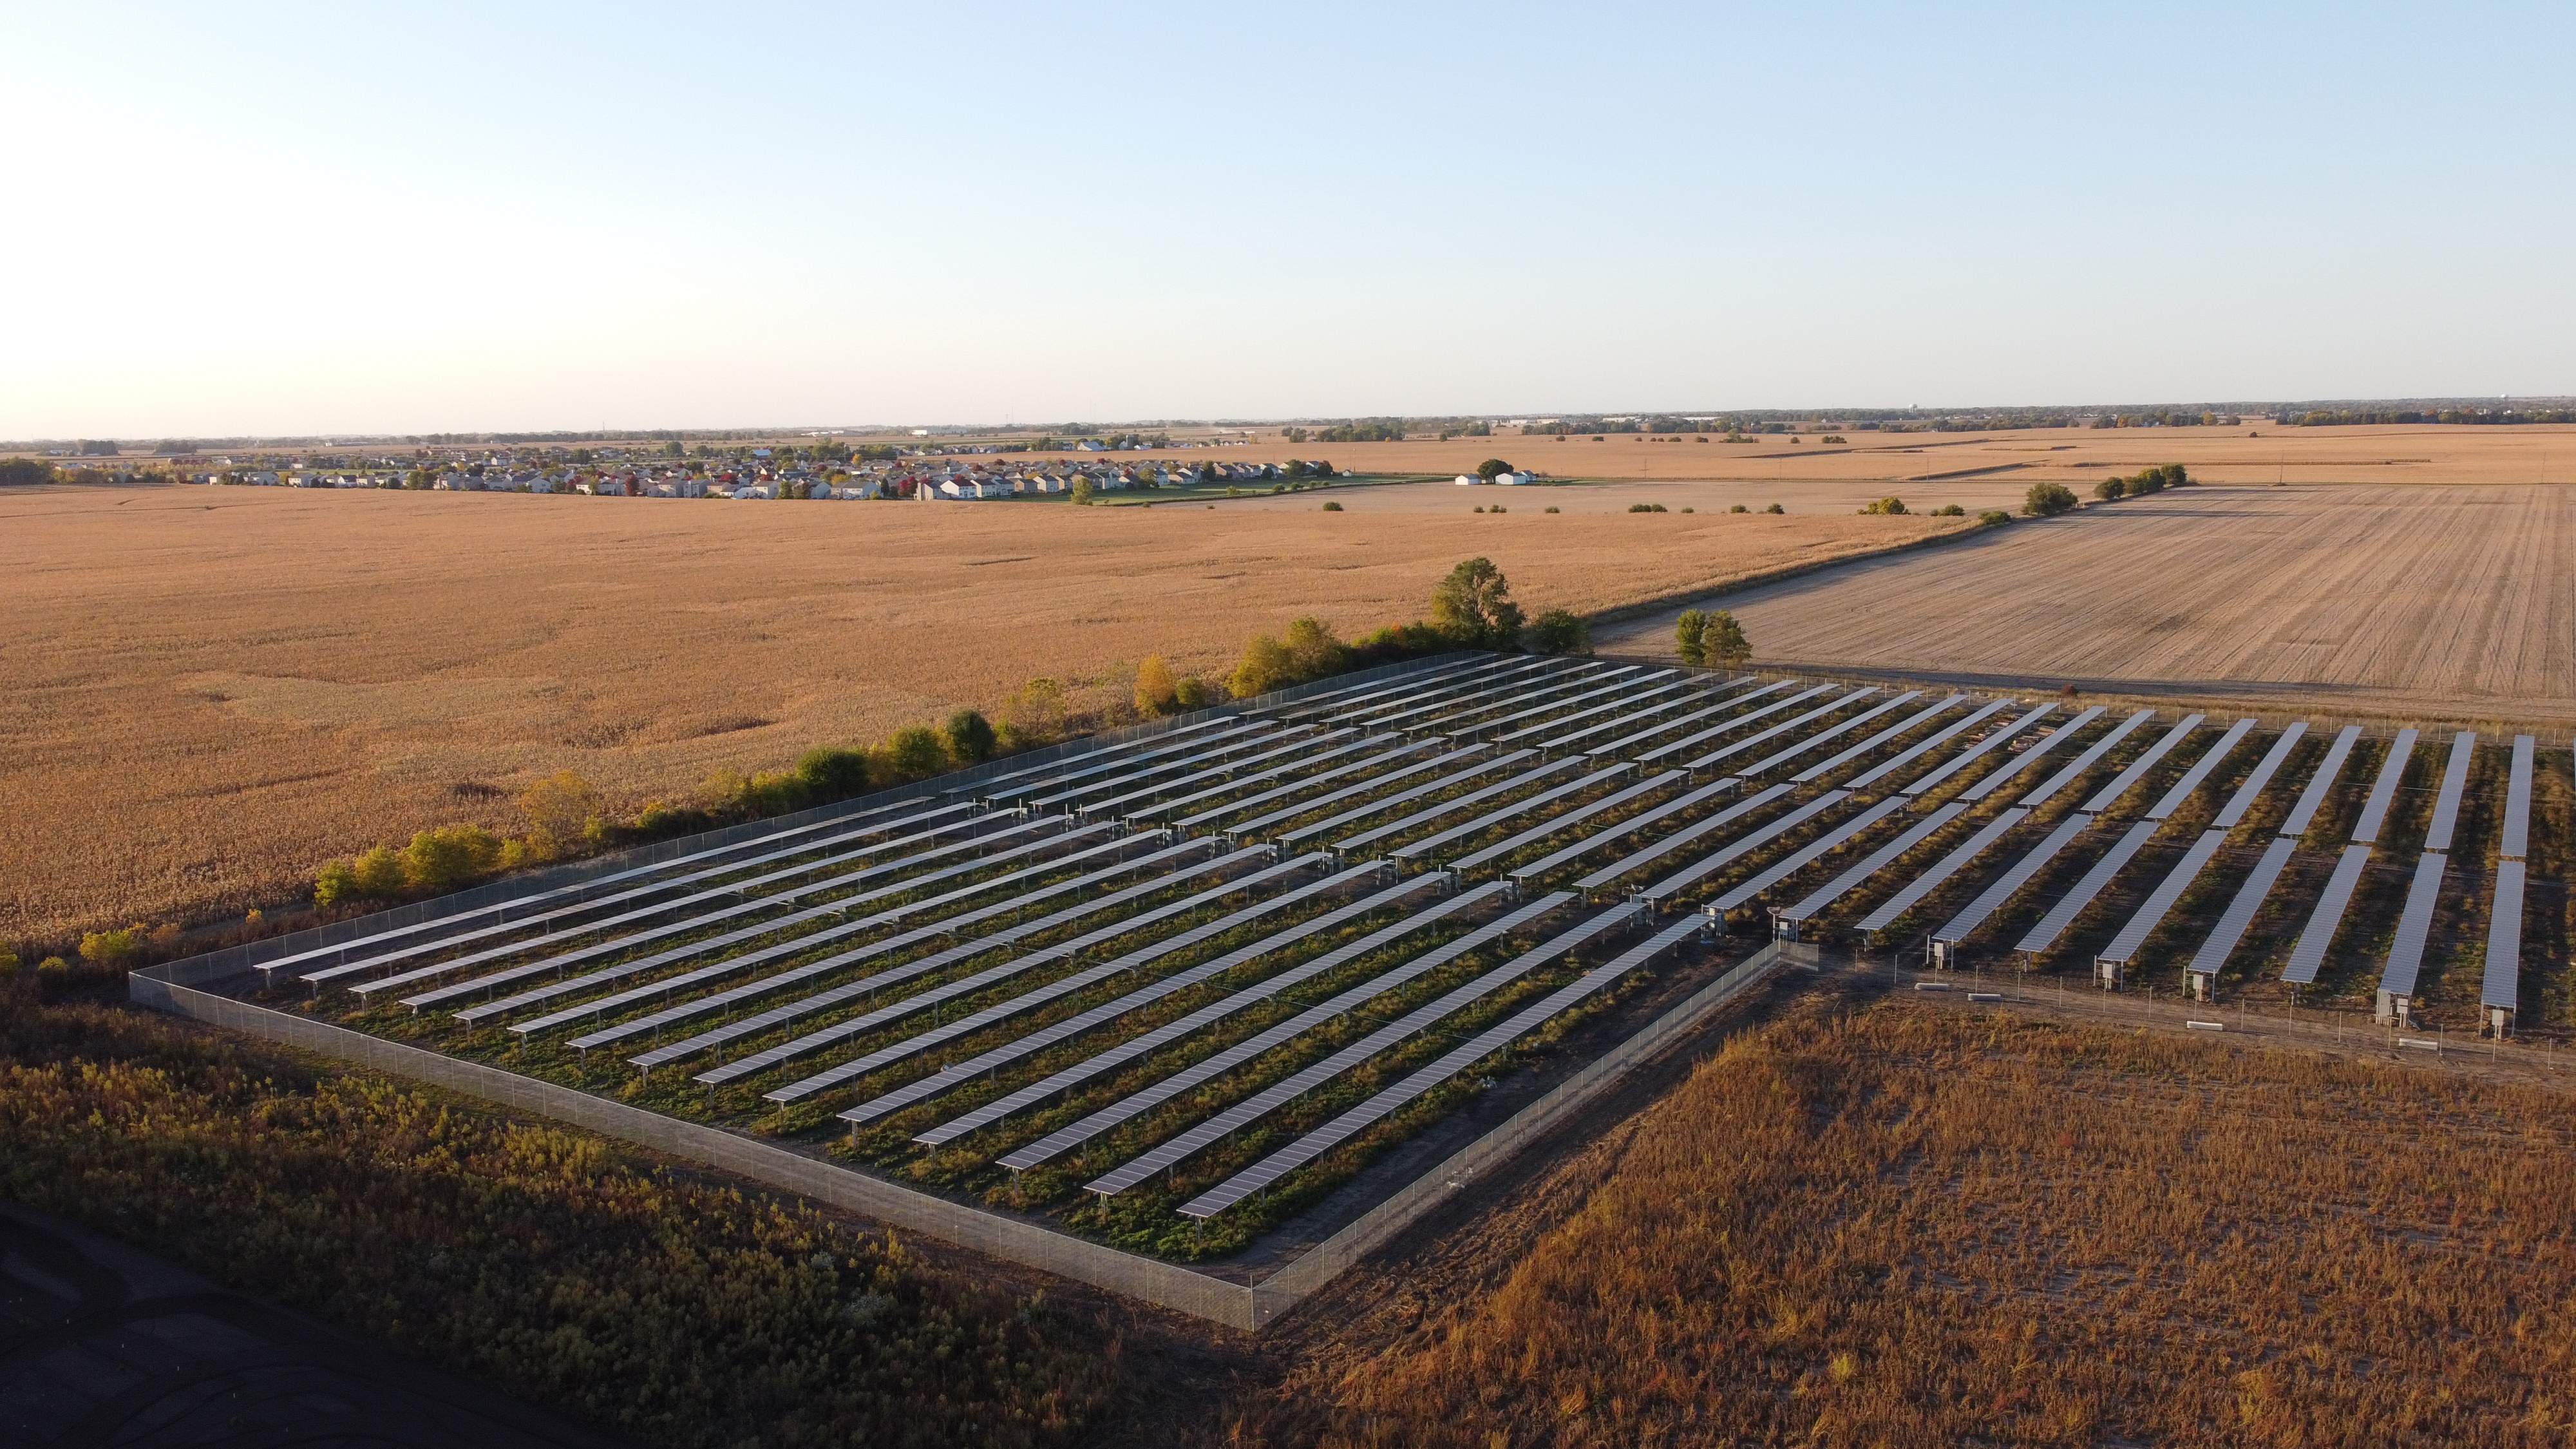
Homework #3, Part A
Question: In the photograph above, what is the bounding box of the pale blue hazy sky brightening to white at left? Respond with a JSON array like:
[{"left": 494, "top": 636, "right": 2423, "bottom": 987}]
[{"left": 0, "top": 0, "right": 2576, "bottom": 439}]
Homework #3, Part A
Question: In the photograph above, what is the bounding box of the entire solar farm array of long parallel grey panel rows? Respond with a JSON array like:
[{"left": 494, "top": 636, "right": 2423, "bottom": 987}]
[{"left": 270, "top": 644, "right": 2532, "bottom": 1242}]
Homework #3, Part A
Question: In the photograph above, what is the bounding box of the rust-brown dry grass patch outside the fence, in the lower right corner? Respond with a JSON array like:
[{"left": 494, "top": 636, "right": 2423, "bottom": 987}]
[{"left": 1226, "top": 1003, "right": 2576, "bottom": 1449}]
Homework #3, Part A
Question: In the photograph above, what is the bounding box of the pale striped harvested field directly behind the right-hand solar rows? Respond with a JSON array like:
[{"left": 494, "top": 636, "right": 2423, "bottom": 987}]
[{"left": 1600, "top": 488, "right": 2576, "bottom": 724}]
